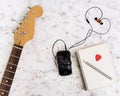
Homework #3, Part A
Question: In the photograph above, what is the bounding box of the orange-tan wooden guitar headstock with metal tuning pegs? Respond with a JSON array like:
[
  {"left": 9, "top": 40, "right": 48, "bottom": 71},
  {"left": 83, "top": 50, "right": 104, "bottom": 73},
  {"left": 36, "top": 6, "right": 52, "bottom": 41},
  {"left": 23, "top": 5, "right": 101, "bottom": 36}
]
[{"left": 14, "top": 6, "right": 43, "bottom": 46}]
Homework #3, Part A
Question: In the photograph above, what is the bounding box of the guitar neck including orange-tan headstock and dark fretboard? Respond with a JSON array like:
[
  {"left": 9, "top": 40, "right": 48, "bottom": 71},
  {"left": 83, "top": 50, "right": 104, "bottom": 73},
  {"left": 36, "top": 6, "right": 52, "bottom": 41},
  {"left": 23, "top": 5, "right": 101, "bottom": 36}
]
[{"left": 0, "top": 6, "right": 43, "bottom": 96}]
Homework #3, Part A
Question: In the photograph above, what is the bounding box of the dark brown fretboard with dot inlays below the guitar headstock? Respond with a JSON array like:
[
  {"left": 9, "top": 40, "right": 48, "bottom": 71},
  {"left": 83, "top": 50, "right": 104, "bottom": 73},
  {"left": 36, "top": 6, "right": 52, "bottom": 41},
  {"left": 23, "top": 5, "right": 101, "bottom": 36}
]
[{"left": 0, "top": 44, "right": 22, "bottom": 96}]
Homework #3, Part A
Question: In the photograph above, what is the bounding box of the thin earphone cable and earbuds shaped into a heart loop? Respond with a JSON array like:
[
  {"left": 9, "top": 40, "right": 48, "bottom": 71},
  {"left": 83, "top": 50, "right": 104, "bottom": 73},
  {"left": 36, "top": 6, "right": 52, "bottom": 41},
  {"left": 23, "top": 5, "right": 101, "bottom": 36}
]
[{"left": 68, "top": 6, "right": 111, "bottom": 50}]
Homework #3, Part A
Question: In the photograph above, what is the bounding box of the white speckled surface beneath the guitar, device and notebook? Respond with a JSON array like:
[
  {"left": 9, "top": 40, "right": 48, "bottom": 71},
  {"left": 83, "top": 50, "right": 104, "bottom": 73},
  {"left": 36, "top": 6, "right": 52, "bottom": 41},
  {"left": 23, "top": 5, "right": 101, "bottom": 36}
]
[{"left": 0, "top": 0, "right": 120, "bottom": 96}]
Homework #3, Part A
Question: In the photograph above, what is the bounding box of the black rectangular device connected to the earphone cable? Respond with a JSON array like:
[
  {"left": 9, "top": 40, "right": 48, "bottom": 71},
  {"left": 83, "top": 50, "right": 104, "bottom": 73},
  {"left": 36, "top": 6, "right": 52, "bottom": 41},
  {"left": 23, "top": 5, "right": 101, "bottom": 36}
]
[{"left": 56, "top": 50, "right": 72, "bottom": 76}]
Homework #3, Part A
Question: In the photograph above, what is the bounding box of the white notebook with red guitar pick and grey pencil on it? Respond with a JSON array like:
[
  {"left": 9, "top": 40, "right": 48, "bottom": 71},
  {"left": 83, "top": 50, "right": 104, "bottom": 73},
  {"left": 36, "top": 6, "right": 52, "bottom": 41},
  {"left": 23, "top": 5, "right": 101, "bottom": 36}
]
[{"left": 77, "top": 43, "right": 116, "bottom": 90}]
